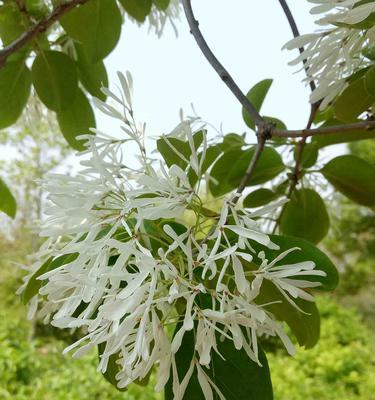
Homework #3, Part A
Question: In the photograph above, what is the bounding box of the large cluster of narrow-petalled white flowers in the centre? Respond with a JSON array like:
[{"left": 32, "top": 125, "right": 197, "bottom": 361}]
[{"left": 19, "top": 74, "right": 325, "bottom": 399}]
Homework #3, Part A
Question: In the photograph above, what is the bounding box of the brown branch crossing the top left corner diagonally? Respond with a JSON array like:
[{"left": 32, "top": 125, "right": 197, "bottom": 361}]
[{"left": 0, "top": 0, "right": 88, "bottom": 68}]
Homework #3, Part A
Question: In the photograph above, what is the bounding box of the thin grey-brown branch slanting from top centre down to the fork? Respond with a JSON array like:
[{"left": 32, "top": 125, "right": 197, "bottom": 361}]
[{"left": 182, "top": 0, "right": 266, "bottom": 127}]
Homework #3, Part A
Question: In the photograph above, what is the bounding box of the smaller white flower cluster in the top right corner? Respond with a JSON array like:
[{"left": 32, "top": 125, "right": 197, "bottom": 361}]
[{"left": 284, "top": 0, "right": 375, "bottom": 109}]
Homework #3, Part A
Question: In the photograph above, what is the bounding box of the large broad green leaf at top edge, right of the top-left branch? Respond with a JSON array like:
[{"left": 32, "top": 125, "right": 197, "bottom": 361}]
[{"left": 60, "top": 0, "right": 122, "bottom": 63}]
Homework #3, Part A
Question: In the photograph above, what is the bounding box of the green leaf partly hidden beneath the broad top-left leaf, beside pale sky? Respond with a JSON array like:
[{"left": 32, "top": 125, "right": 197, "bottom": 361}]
[{"left": 76, "top": 43, "right": 108, "bottom": 101}]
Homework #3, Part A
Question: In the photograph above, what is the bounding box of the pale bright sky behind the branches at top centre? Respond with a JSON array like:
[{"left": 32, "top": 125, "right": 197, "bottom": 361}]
[{"left": 97, "top": 0, "right": 315, "bottom": 138}]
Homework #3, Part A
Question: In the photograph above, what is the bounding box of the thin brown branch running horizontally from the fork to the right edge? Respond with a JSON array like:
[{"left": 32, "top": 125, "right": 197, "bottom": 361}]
[{"left": 272, "top": 121, "right": 375, "bottom": 138}]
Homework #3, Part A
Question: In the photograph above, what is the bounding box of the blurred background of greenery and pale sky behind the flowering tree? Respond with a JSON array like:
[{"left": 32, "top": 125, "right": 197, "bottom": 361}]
[{"left": 0, "top": 0, "right": 375, "bottom": 400}]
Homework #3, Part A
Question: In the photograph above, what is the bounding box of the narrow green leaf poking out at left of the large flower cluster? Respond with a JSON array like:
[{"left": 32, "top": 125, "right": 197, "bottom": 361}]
[{"left": 22, "top": 253, "right": 78, "bottom": 304}]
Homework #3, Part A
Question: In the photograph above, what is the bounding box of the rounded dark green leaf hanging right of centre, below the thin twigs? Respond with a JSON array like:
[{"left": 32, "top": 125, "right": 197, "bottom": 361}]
[{"left": 280, "top": 189, "right": 329, "bottom": 243}]
